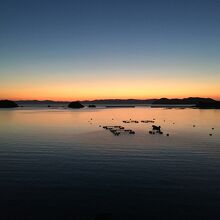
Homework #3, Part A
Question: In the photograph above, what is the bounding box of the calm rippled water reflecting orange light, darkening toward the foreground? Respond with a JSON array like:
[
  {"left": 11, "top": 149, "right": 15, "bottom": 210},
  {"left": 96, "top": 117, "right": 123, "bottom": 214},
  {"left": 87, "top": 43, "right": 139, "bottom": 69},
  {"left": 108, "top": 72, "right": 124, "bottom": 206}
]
[{"left": 0, "top": 107, "right": 220, "bottom": 220}]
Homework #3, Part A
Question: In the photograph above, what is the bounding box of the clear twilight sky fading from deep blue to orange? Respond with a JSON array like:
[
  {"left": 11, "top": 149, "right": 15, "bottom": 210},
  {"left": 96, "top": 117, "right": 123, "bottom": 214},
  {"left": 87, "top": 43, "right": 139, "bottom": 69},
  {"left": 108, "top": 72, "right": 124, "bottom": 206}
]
[{"left": 0, "top": 0, "right": 220, "bottom": 101}]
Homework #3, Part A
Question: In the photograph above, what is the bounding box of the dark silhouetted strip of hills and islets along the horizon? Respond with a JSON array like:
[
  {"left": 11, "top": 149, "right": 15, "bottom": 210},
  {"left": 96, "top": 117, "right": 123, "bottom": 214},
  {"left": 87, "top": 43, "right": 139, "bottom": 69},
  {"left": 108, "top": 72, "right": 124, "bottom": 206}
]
[{"left": 0, "top": 97, "right": 220, "bottom": 109}]
